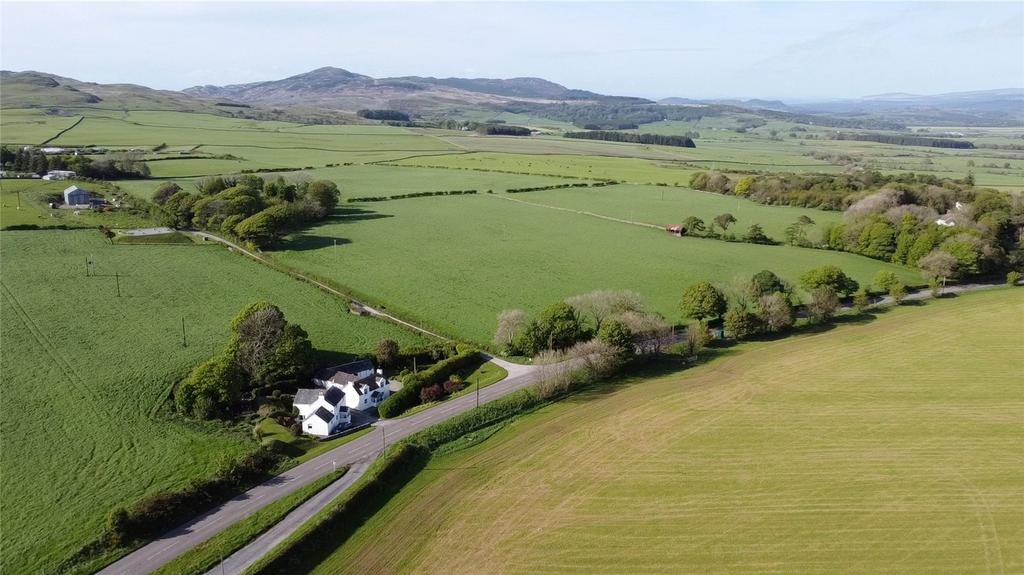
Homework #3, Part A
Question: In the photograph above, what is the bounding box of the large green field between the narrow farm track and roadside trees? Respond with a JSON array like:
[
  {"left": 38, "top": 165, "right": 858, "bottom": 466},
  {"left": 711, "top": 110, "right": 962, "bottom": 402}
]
[{"left": 270, "top": 192, "right": 920, "bottom": 342}]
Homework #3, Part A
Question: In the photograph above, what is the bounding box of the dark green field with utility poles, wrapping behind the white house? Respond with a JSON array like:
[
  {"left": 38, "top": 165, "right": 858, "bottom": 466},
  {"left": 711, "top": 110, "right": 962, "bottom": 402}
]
[{"left": 0, "top": 230, "right": 423, "bottom": 573}]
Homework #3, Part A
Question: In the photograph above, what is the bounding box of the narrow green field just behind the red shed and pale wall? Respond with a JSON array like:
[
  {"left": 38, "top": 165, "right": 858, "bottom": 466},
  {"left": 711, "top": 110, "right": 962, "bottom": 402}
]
[{"left": 516, "top": 184, "right": 843, "bottom": 241}]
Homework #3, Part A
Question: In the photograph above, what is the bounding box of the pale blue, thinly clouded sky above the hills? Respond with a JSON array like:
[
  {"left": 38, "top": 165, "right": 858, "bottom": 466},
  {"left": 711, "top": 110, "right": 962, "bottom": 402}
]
[{"left": 0, "top": 1, "right": 1024, "bottom": 101}]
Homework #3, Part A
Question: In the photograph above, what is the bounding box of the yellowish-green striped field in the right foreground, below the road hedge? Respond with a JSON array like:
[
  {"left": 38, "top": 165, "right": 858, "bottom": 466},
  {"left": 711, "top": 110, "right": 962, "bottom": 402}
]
[{"left": 314, "top": 289, "right": 1024, "bottom": 574}]
